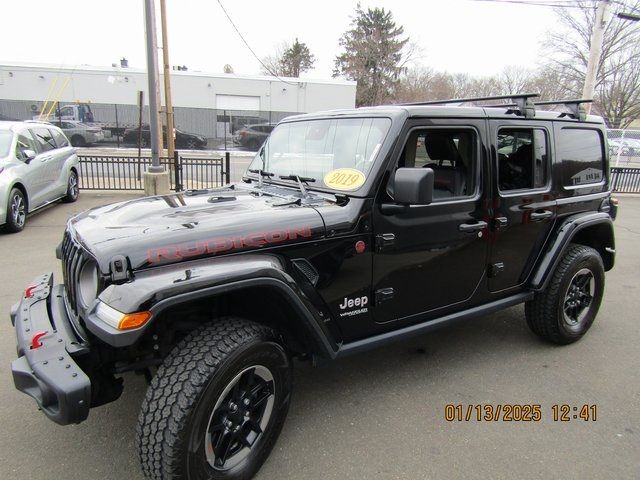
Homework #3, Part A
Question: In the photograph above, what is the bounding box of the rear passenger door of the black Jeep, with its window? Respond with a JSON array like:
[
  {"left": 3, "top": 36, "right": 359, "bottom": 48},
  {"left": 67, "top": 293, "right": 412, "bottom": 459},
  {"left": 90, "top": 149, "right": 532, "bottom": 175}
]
[{"left": 488, "top": 120, "right": 557, "bottom": 292}]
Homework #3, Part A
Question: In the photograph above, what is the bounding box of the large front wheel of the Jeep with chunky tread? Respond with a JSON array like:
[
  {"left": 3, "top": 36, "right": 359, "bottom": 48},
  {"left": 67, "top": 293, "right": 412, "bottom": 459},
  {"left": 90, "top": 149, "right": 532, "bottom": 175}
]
[{"left": 137, "top": 318, "right": 292, "bottom": 480}]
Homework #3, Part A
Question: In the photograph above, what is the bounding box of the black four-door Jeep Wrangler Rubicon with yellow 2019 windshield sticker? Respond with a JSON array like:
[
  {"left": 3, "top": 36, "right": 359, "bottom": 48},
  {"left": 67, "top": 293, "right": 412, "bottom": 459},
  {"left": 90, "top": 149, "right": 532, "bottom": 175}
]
[{"left": 11, "top": 95, "right": 615, "bottom": 479}]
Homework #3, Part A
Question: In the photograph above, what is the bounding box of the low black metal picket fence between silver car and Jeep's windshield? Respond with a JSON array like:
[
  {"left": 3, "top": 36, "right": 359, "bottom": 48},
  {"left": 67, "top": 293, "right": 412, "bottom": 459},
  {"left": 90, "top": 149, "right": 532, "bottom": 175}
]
[{"left": 78, "top": 152, "right": 231, "bottom": 192}]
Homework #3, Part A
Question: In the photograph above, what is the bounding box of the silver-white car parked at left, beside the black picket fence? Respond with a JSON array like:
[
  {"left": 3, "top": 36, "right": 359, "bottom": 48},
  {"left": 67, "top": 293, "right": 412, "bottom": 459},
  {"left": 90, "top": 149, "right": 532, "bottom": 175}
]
[{"left": 0, "top": 122, "right": 80, "bottom": 232}]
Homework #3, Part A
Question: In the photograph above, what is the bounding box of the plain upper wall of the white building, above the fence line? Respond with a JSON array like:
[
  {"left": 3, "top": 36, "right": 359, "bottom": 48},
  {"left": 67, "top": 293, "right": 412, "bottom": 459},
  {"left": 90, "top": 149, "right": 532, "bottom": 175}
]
[{"left": 0, "top": 64, "right": 356, "bottom": 112}]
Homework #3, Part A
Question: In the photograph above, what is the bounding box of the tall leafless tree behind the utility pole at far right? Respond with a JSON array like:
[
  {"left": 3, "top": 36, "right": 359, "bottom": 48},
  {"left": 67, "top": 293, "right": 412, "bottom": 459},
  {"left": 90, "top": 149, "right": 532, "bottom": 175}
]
[{"left": 544, "top": 0, "right": 640, "bottom": 128}]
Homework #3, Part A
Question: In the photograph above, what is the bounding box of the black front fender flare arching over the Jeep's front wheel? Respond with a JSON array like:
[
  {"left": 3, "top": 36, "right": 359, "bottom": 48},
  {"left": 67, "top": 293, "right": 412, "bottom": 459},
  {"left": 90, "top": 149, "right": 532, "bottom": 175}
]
[{"left": 86, "top": 254, "right": 338, "bottom": 358}]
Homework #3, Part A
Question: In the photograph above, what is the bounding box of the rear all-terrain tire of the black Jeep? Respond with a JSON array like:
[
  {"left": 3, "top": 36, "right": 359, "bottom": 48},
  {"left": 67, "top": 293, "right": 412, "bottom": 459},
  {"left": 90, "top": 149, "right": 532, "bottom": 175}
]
[{"left": 525, "top": 244, "right": 604, "bottom": 345}]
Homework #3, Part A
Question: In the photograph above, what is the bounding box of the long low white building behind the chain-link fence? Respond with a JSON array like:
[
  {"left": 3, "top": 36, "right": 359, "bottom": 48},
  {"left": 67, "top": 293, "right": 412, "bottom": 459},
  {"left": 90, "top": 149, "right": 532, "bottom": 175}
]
[{"left": 0, "top": 63, "right": 356, "bottom": 138}]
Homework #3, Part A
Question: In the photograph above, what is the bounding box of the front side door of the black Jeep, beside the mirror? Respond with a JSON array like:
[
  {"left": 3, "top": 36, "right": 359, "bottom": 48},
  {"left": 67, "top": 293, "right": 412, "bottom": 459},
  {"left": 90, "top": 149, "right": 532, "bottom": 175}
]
[{"left": 373, "top": 119, "right": 489, "bottom": 325}]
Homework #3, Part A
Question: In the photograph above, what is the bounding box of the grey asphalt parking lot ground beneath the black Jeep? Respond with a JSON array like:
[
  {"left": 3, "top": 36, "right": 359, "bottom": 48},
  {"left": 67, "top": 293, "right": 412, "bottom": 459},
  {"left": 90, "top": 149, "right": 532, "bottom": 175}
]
[{"left": 0, "top": 192, "right": 640, "bottom": 480}]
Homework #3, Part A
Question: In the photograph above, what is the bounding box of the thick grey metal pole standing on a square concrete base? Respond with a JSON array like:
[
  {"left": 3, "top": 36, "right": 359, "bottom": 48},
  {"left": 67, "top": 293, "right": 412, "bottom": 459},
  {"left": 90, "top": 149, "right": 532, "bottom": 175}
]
[{"left": 144, "top": 0, "right": 169, "bottom": 195}]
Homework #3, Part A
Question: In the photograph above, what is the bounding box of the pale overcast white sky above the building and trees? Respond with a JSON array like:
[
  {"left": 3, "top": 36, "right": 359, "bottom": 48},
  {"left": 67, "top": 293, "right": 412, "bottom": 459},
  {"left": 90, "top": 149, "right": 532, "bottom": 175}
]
[{"left": 0, "top": 0, "right": 554, "bottom": 78}]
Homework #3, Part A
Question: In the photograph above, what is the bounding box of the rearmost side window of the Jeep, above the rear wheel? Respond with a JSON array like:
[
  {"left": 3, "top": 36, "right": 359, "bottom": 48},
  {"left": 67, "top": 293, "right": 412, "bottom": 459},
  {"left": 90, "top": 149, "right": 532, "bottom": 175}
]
[{"left": 558, "top": 128, "right": 604, "bottom": 187}]
